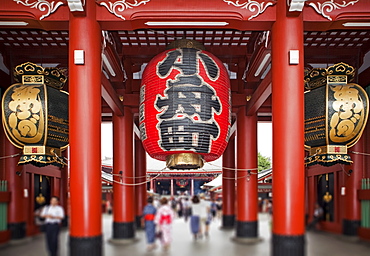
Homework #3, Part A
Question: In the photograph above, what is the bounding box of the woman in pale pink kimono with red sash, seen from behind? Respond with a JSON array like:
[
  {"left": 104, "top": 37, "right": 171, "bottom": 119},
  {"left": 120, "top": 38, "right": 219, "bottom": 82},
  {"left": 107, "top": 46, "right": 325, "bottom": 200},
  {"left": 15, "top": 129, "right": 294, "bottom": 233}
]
[{"left": 154, "top": 197, "right": 175, "bottom": 251}]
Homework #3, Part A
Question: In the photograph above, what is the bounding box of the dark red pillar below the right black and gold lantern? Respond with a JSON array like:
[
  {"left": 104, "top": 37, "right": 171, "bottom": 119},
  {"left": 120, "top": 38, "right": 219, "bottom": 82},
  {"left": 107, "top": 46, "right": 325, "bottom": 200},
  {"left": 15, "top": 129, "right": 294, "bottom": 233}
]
[{"left": 342, "top": 137, "right": 365, "bottom": 236}]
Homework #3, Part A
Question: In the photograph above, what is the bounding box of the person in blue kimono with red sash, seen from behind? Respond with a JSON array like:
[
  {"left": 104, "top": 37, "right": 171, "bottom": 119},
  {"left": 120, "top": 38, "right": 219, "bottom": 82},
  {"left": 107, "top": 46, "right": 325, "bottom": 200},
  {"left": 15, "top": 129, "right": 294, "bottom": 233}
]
[{"left": 143, "top": 196, "right": 157, "bottom": 251}]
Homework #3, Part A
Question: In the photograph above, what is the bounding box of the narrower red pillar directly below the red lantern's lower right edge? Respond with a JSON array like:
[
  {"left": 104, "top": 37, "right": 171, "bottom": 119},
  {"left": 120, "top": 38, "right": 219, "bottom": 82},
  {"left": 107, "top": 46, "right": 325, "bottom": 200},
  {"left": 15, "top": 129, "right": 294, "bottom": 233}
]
[{"left": 222, "top": 137, "right": 235, "bottom": 228}]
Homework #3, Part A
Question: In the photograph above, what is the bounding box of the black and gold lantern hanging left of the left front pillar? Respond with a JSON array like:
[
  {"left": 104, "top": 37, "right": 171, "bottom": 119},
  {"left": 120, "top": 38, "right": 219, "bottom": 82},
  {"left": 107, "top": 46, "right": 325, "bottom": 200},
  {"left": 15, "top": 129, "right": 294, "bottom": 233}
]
[{"left": 2, "top": 62, "right": 69, "bottom": 166}]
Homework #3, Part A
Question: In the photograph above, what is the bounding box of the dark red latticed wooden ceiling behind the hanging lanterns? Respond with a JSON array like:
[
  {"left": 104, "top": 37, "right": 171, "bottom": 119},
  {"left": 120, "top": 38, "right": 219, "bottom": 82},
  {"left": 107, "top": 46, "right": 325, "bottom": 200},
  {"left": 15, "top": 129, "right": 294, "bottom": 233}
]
[{"left": 0, "top": 29, "right": 370, "bottom": 120}]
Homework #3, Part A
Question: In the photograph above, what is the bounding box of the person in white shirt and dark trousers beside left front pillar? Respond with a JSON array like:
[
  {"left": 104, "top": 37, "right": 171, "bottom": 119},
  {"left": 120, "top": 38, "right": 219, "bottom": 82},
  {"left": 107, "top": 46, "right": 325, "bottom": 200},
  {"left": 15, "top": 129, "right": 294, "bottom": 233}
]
[{"left": 41, "top": 196, "right": 64, "bottom": 256}]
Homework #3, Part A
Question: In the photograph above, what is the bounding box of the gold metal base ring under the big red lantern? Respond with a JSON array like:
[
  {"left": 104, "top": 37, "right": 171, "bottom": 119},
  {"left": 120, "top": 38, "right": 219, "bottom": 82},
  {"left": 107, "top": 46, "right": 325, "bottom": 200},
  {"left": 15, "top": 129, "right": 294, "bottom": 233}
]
[{"left": 166, "top": 153, "right": 203, "bottom": 169}]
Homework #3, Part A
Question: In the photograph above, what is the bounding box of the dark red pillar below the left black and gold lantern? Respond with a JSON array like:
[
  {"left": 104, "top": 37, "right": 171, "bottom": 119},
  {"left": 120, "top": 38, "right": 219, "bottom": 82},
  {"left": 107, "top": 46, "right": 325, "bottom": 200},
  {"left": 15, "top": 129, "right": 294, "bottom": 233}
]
[{"left": 3, "top": 136, "right": 28, "bottom": 240}]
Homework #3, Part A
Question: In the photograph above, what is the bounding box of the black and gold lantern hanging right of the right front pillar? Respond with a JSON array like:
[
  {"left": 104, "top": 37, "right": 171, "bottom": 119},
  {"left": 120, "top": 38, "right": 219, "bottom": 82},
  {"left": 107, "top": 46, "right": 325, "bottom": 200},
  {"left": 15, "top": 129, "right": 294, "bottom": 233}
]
[{"left": 305, "top": 63, "right": 369, "bottom": 166}]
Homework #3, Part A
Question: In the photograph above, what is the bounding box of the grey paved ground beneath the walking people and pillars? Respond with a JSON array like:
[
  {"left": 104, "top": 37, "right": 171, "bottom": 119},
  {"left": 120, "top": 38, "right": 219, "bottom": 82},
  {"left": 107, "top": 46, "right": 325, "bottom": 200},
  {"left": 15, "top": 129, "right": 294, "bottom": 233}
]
[{"left": 0, "top": 215, "right": 370, "bottom": 256}]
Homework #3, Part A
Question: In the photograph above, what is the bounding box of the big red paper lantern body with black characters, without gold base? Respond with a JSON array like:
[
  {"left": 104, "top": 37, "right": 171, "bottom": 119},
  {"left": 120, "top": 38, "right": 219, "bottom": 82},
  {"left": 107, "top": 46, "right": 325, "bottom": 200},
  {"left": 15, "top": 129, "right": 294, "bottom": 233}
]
[{"left": 140, "top": 48, "right": 231, "bottom": 161}]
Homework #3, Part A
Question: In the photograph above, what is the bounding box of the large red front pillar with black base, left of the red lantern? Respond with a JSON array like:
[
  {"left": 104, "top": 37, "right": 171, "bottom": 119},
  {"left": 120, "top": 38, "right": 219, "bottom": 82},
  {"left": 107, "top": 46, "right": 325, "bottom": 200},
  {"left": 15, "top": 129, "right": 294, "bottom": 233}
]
[{"left": 68, "top": 1, "right": 103, "bottom": 256}]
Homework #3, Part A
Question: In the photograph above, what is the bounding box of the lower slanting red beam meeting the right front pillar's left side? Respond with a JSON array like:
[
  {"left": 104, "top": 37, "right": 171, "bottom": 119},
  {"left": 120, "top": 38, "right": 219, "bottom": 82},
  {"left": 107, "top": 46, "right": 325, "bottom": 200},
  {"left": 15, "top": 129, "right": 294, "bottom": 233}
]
[{"left": 247, "top": 69, "right": 272, "bottom": 116}]
